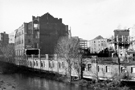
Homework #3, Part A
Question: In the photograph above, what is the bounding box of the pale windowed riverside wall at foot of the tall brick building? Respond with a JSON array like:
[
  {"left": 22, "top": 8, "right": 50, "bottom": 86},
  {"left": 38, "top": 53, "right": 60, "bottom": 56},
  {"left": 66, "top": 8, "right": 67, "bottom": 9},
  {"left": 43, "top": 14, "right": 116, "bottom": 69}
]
[{"left": 24, "top": 54, "right": 78, "bottom": 77}]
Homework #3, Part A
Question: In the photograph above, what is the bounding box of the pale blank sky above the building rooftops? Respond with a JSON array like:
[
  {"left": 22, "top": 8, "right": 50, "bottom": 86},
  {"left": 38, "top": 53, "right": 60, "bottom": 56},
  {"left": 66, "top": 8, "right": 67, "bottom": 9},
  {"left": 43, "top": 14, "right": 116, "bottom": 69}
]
[{"left": 0, "top": 0, "right": 135, "bottom": 40}]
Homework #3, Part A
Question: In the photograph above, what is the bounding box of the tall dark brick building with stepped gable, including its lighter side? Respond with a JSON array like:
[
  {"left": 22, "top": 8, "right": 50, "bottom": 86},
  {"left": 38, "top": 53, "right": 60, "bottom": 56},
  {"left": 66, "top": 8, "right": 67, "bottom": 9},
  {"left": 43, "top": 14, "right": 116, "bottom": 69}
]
[{"left": 15, "top": 13, "right": 69, "bottom": 55}]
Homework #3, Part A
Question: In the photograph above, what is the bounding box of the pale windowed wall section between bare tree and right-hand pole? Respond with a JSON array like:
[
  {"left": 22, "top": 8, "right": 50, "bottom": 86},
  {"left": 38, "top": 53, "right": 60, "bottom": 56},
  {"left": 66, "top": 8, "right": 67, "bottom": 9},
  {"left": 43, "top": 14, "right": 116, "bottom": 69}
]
[{"left": 84, "top": 63, "right": 123, "bottom": 79}]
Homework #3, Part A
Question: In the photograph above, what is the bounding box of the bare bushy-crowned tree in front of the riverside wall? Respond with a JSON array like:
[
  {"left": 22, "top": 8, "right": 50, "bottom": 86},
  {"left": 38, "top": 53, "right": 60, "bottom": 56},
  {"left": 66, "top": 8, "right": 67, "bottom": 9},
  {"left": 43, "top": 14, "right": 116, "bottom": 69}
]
[{"left": 55, "top": 37, "right": 80, "bottom": 81}]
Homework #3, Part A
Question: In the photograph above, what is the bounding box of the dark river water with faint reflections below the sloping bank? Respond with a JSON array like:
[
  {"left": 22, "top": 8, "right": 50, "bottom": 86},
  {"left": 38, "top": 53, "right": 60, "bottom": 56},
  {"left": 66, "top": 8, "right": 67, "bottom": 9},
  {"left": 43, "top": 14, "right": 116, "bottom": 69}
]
[{"left": 0, "top": 74, "right": 86, "bottom": 90}]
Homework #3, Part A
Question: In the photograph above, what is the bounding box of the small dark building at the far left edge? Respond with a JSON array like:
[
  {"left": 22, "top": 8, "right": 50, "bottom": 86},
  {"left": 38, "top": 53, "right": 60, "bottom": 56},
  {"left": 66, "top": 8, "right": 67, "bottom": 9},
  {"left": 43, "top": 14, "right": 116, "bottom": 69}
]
[{"left": 0, "top": 32, "right": 9, "bottom": 46}]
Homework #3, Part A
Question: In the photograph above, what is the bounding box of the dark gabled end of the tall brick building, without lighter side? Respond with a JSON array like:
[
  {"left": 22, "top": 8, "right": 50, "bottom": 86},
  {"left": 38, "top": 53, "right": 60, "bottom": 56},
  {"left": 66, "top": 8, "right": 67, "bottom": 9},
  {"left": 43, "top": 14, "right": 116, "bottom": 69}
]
[{"left": 32, "top": 13, "right": 69, "bottom": 54}]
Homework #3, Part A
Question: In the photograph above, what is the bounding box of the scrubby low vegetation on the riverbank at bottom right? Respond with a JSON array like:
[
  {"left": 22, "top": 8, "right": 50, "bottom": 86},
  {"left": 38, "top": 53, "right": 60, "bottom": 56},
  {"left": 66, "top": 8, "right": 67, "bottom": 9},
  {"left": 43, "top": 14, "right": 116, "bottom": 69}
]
[{"left": 72, "top": 80, "right": 132, "bottom": 90}]
